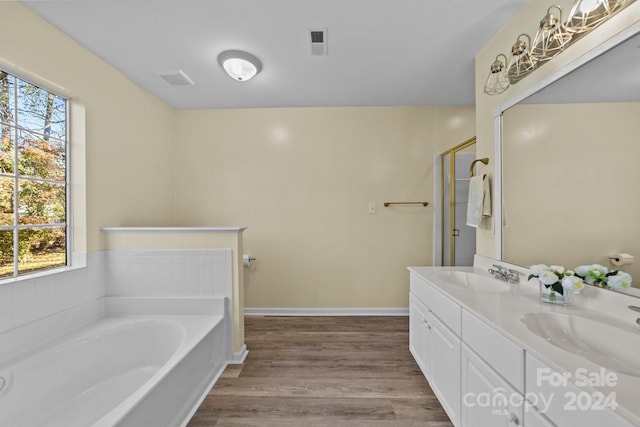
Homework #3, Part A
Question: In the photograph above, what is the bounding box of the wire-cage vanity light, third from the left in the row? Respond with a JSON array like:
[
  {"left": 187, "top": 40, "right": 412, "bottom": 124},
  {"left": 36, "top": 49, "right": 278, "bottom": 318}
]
[{"left": 531, "top": 4, "right": 572, "bottom": 65}]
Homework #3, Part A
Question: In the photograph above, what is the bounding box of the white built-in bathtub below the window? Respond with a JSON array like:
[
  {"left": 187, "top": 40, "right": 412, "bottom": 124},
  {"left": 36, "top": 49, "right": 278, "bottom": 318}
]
[{"left": 0, "top": 315, "right": 228, "bottom": 427}]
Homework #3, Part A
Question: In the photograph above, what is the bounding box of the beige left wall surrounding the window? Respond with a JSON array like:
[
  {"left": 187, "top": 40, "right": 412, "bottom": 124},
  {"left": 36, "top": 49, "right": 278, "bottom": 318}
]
[{"left": 0, "top": 1, "right": 174, "bottom": 251}]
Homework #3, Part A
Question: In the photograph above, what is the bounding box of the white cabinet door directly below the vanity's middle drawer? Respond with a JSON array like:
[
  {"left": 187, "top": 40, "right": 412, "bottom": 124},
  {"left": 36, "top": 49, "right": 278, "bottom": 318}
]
[{"left": 460, "top": 344, "right": 524, "bottom": 427}]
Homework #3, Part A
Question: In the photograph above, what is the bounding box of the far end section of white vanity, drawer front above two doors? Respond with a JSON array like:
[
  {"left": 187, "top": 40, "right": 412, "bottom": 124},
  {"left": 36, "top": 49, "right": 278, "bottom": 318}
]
[{"left": 409, "top": 276, "right": 461, "bottom": 425}]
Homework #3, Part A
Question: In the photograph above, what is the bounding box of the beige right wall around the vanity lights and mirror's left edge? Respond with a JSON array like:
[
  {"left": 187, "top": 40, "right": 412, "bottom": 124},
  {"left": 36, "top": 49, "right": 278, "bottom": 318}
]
[{"left": 476, "top": 0, "right": 640, "bottom": 257}]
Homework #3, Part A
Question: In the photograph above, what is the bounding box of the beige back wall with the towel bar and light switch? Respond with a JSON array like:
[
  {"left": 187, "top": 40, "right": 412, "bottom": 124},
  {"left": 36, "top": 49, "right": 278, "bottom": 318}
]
[{"left": 175, "top": 107, "right": 474, "bottom": 308}]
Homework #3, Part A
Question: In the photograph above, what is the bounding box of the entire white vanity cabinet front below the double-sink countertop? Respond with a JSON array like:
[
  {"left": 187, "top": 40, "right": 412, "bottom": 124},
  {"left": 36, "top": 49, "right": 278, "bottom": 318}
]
[{"left": 409, "top": 271, "right": 635, "bottom": 427}]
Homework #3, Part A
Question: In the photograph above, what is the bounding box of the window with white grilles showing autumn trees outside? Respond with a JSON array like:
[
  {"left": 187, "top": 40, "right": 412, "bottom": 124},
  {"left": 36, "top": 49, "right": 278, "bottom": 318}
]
[{"left": 0, "top": 70, "right": 68, "bottom": 279}]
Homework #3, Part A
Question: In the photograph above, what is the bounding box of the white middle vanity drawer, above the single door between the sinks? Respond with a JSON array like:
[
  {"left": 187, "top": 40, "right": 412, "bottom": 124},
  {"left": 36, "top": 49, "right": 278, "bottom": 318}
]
[{"left": 462, "top": 310, "right": 524, "bottom": 393}]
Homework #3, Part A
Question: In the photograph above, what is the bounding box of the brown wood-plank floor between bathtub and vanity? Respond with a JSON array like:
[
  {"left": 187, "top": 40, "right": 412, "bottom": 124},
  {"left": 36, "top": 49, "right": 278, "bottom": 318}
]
[{"left": 188, "top": 316, "right": 452, "bottom": 427}]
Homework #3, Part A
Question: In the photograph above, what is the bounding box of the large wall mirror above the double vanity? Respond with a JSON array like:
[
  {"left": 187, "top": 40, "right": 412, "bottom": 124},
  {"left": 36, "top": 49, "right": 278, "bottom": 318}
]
[{"left": 502, "top": 27, "right": 640, "bottom": 287}]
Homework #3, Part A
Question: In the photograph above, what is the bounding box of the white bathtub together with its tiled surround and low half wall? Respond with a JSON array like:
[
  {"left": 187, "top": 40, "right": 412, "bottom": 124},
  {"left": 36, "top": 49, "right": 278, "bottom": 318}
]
[{"left": 0, "top": 234, "right": 238, "bottom": 427}]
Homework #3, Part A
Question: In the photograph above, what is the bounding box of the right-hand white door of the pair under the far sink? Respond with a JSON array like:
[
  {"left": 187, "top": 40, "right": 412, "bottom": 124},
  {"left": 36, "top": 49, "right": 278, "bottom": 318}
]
[{"left": 427, "top": 312, "right": 461, "bottom": 426}]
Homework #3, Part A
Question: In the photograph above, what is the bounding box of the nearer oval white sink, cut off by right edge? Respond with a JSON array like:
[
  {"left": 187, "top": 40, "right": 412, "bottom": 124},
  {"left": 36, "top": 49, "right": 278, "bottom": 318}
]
[{"left": 522, "top": 313, "right": 640, "bottom": 377}]
